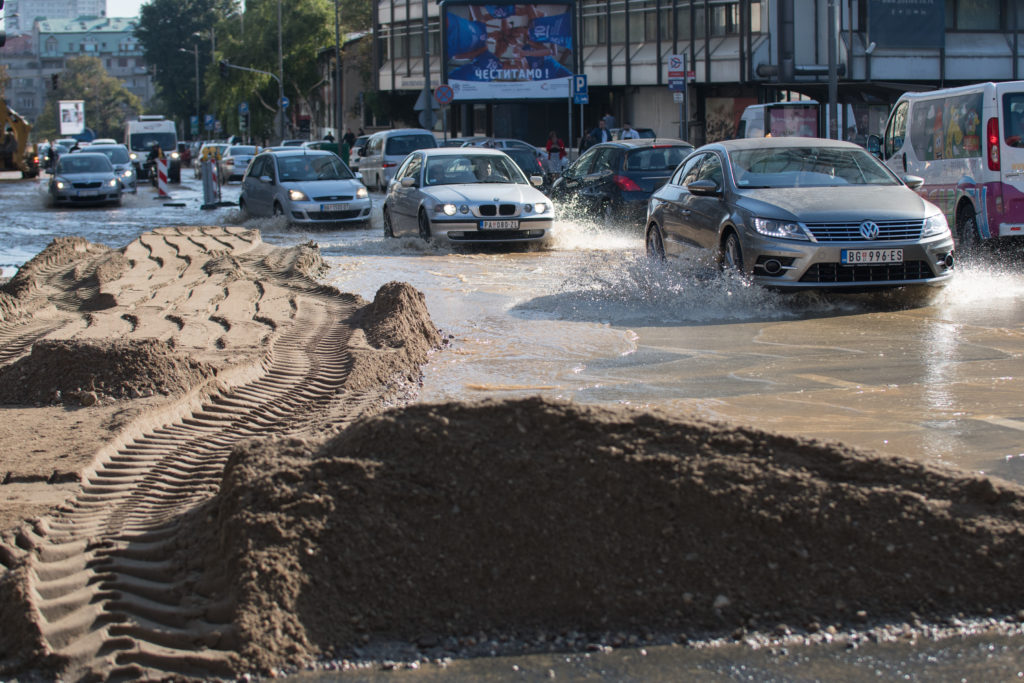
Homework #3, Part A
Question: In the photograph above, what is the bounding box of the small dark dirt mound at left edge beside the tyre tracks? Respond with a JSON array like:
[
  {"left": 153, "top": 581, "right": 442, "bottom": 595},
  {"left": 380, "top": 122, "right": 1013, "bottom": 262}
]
[{"left": 0, "top": 339, "right": 217, "bottom": 404}]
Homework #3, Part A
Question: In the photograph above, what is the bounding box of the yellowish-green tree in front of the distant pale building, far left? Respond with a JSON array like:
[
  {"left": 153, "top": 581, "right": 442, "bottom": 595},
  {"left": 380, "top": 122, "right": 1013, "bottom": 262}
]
[{"left": 35, "top": 56, "right": 142, "bottom": 139}]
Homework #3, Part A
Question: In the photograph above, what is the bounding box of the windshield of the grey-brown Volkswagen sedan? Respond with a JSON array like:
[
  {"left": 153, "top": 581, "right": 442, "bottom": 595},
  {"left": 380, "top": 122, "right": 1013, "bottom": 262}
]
[{"left": 729, "top": 146, "right": 898, "bottom": 189}]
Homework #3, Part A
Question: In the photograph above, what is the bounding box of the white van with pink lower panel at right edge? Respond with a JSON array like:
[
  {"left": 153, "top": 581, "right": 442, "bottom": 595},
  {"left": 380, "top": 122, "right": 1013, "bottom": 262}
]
[{"left": 881, "top": 81, "right": 1024, "bottom": 249}]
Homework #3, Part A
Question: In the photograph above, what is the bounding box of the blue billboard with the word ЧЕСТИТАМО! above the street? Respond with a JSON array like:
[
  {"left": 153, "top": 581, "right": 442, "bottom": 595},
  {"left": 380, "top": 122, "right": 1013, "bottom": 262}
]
[{"left": 442, "top": 3, "right": 572, "bottom": 100}]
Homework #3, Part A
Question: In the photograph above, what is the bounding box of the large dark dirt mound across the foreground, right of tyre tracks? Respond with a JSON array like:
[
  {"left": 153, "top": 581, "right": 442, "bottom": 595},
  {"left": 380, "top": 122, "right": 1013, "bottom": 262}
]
[{"left": 205, "top": 398, "right": 1024, "bottom": 667}]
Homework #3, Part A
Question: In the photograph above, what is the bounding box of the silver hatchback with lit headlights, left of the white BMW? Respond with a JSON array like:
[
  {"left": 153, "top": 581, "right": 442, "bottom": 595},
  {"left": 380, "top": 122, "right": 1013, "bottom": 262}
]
[{"left": 239, "top": 147, "right": 371, "bottom": 226}]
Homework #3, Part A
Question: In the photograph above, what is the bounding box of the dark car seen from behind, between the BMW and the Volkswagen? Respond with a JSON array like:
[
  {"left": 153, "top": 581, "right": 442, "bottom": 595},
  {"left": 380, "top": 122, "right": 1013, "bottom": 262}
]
[{"left": 551, "top": 138, "right": 693, "bottom": 226}]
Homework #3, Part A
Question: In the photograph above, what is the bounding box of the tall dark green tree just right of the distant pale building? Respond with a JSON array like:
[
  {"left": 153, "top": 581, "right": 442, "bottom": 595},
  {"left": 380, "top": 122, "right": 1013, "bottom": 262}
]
[{"left": 135, "top": 0, "right": 234, "bottom": 127}]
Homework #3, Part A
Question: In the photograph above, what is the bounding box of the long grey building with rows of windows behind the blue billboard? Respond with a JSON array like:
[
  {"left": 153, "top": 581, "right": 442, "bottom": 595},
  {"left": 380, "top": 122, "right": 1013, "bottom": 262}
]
[{"left": 374, "top": 0, "right": 1024, "bottom": 148}]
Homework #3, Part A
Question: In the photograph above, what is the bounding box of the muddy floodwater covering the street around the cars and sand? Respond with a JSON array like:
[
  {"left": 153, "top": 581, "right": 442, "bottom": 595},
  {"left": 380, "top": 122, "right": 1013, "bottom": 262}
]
[{"left": 6, "top": 170, "right": 1024, "bottom": 681}]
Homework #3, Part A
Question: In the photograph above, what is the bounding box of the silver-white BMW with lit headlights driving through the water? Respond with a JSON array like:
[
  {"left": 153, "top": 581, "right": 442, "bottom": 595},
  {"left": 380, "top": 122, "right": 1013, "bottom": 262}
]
[{"left": 383, "top": 147, "right": 554, "bottom": 244}]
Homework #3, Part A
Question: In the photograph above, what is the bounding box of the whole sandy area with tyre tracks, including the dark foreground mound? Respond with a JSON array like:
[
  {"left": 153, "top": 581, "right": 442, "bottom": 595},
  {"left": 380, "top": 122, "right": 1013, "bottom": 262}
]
[{"left": 6, "top": 227, "right": 1024, "bottom": 680}]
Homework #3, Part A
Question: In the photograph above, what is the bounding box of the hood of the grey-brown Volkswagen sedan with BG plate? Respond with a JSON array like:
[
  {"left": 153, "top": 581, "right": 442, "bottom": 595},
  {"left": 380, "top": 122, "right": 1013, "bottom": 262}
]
[{"left": 737, "top": 185, "right": 938, "bottom": 223}]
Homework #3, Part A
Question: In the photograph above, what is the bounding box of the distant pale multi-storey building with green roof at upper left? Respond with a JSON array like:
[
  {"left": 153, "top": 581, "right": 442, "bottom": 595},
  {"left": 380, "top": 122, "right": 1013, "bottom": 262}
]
[{"left": 0, "top": 16, "right": 155, "bottom": 121}]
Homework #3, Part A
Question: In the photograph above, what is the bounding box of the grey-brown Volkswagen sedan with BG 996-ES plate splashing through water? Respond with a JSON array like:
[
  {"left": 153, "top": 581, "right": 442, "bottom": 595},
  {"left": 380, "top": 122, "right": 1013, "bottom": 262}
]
[{"left": 646, "top": 137, "right": 953, "bottom": 290}]
